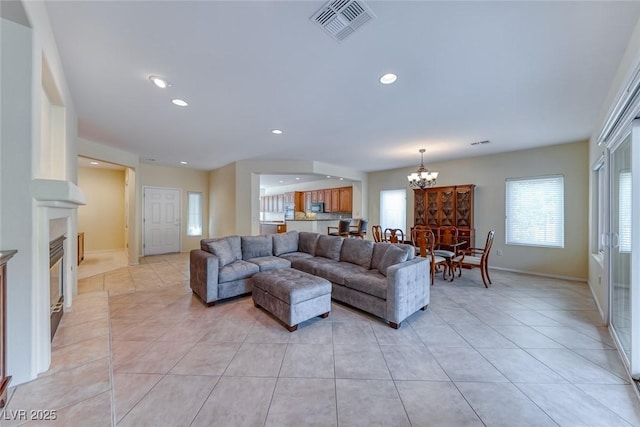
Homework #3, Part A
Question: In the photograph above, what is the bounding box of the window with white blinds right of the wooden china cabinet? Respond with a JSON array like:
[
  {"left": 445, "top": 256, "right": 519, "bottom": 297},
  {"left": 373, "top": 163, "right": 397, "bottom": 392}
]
[{"left": 505, "top": 175, "right": 564, "bottom": 248}]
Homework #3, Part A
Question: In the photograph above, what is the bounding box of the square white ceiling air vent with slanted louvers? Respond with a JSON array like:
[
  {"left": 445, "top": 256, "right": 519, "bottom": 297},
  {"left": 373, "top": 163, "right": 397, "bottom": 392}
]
[{"left": 310, "top": 0, "right": 376, "bottom": 41}]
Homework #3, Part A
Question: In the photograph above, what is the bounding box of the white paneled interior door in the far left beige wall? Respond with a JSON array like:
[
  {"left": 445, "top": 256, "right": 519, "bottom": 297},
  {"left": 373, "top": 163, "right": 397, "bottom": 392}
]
[{"left": 142, "top": 187, "right": 182, "bottom": 255}]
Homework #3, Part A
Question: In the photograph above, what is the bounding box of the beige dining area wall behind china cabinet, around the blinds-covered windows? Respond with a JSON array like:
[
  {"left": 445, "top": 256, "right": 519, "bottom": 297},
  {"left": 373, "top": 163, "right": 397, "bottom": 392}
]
[{"left": 369, "top": 142, "right": 589, "bottom": 280}]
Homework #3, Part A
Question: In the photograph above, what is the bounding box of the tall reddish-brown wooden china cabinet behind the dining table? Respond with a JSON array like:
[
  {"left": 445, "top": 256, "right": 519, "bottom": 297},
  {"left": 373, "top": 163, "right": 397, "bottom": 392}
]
[{"left": 413, "top": 184, "right": 476, "bottom": 248}]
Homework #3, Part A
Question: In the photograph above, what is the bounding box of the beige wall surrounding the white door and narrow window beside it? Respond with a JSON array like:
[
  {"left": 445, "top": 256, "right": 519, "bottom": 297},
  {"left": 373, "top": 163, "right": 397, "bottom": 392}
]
[{"left": 136, "top": 163, "right": 209, "bottom": 252}]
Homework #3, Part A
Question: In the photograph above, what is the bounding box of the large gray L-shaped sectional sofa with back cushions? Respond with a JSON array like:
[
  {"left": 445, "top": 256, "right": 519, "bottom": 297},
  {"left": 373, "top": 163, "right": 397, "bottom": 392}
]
[{"left": 190, "top": 231, "right": 431, "bottom": 328}]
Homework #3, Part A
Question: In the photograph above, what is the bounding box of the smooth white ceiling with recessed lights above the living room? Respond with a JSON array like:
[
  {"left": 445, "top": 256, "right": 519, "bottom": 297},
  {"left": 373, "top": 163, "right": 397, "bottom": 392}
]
[{"left": 47, "top": 1, "right": 640, "bottom": 171}]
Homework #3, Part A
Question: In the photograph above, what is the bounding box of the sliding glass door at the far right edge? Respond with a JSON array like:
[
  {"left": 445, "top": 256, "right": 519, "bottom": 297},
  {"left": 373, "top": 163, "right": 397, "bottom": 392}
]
[{"left": 609, "top": 120, "right": 640, "bottom": 378}]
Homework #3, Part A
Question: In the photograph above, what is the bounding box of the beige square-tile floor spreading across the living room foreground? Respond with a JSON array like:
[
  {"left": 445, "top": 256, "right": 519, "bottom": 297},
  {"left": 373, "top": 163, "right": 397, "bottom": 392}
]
[{"left": 2, "top": 254, "right": 640, "bottom": 427}]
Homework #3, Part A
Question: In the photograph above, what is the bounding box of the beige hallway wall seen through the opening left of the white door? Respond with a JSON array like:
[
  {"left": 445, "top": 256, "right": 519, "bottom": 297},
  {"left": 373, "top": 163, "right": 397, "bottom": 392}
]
[{"left": 78, "top": 168, "right": 125, "bottom": 252}]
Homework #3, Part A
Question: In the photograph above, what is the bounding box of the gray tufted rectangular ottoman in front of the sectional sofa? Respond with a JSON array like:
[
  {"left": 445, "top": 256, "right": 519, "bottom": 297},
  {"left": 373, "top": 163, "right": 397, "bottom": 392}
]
[{"left": 253, "top": 268, "right": 331, "bottom": 332}]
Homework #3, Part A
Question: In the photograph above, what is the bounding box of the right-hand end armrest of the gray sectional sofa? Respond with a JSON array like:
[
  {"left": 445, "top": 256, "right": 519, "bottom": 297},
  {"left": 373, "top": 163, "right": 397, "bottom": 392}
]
[{"left": 387, "top": 257, "right": 431, "bottom": 325}]
